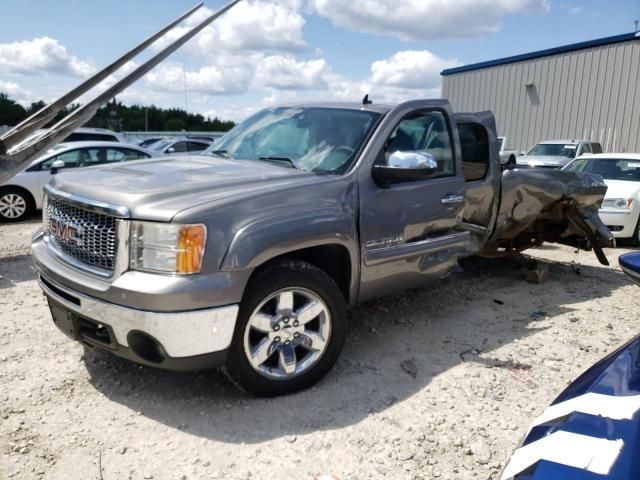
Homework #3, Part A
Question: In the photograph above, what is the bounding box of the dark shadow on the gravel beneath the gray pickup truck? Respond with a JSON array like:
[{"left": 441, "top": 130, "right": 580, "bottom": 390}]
[{"left": 84, "top": 253, "right": 628, "bottom": 443}]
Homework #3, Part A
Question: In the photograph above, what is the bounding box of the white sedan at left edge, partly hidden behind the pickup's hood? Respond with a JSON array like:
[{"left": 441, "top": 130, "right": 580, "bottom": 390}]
[{"left": 0, "top": 141, "right": 158, "bottom": 222}]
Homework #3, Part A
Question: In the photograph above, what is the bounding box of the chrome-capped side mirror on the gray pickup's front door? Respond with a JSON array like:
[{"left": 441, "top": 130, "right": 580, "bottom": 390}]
[{"left": 373, "top": 151, "right": 438, "bottom": 187}]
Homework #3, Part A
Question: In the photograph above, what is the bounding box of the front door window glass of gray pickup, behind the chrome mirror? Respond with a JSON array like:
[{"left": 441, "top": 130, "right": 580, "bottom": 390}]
[{"left": 384, "top": 111, "right": 455, "bottom": 178}]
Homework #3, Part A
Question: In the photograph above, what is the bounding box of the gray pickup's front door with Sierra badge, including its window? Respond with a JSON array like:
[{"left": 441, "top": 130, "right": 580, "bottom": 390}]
[{"left": 359, "top": 101, "right": 470, "bottom": 299}]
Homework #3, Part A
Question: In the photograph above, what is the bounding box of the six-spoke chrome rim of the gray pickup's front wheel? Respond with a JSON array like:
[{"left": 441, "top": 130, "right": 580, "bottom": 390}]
[{"left": 244, "top": 287, "right": 331, "bottom": 380}]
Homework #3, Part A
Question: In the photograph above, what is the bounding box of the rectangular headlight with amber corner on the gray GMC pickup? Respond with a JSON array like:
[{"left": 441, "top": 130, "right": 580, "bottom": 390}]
[{"left": 130, "top": 222, "right": 207, "bottom": 275}]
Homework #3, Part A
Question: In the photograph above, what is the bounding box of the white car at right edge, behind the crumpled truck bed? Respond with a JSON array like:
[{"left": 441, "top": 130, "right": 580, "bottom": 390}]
[{"left": 564, "top": 153, "right": 640, "bottom": 246}]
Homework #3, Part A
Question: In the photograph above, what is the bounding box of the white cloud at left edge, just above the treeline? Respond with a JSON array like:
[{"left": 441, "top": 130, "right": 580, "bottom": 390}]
[{"left": 0, "top": 37, "right": 93, "bottom": 77}]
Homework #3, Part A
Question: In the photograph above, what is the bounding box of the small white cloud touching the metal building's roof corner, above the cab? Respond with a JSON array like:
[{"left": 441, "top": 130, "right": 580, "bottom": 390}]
[{"left": 371, "top": 50, "right": 460, "bottom": 89}]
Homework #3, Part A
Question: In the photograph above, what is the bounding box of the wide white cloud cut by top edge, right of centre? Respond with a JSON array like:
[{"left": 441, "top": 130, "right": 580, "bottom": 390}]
[{"left": 309, "top": 0, "right": 550, "bottom": 40}]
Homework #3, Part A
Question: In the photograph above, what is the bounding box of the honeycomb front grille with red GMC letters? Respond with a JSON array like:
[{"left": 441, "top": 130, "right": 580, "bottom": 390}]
[{"left": 43, "top": 196, "right": 117, "bottom": 271}]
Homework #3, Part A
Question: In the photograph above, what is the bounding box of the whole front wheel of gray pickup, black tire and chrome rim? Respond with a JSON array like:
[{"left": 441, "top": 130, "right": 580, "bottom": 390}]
[{"left": 225, "top": 260, "right": 347, "bottom": 397}]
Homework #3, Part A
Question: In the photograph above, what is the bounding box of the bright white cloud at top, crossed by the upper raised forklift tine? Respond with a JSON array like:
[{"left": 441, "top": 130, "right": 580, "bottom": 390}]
[{"left": 154, "top": 0, "right": 308, "bottom": 58}]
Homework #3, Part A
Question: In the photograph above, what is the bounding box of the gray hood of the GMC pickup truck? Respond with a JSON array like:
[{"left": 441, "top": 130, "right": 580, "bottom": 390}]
[{"left": 50, "top": 156, "right": 319, "bottom": 222}]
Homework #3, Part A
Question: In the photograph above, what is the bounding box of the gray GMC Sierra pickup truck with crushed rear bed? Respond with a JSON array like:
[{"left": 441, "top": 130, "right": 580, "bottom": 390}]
[{"left": 33, "top": 100, "right": 613, "bottom": 396}]
